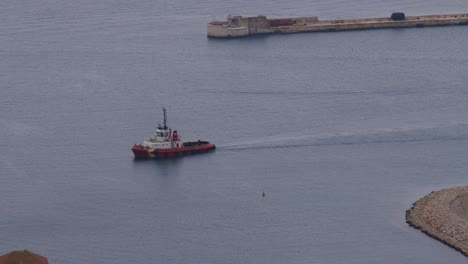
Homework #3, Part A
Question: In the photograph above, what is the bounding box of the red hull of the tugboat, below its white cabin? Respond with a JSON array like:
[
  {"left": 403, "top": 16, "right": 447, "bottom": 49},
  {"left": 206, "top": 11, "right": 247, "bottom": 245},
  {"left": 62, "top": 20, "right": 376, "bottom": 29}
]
[{"left": 132, "top": 142, "right": 216, "bottom": 159}]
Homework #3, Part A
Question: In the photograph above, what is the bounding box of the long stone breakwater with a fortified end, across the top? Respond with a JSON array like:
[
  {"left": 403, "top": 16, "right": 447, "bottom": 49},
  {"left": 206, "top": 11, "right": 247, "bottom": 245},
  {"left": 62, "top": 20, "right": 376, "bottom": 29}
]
[{"left": 208, "top": 13, "right": 468, "bottom": 38}]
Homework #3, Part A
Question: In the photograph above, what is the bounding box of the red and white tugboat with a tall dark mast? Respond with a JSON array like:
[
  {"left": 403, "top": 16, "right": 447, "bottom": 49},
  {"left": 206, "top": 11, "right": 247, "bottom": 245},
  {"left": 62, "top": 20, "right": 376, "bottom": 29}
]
[{"left": 132, "top": 108, "right": 216, "bottom": 158}]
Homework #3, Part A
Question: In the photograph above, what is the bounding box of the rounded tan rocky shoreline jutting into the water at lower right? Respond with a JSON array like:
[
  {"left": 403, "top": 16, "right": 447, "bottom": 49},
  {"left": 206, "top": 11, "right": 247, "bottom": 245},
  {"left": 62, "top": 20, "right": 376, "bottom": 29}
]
[{"left": 406, "top": 186, "right": 468, "bottom": 256}]
